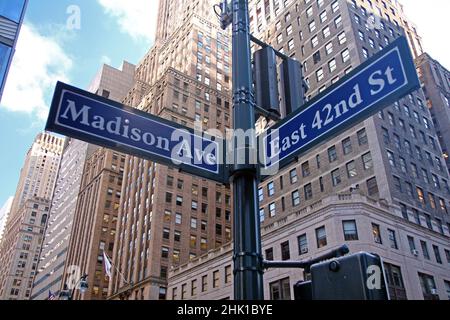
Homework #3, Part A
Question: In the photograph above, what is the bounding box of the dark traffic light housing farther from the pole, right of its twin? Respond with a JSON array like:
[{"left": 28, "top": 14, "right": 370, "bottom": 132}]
[{"left": 280, "top": 58, "right": 307, "bottom": 116}]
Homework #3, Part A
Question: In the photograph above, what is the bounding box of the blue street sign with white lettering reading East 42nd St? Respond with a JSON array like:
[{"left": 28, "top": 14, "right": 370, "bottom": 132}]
[{"left": 258, "top": 37, "right": 420, "bottom": 176}]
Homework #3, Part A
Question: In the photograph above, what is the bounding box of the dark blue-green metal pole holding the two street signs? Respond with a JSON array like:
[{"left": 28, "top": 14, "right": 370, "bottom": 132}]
[{"left": 232, "top": 0, "right": 264, "bottom": 300}]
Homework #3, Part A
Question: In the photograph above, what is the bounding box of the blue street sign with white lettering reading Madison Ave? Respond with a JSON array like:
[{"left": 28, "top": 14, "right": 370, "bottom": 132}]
[{"left": 46, "top": 82, "right": 228, "bottom": 183}]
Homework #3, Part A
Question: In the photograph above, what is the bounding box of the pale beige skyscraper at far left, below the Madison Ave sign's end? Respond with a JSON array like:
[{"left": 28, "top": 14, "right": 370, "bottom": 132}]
[{"left": 0, "top": 133, "right": 64, "bottom": 299}]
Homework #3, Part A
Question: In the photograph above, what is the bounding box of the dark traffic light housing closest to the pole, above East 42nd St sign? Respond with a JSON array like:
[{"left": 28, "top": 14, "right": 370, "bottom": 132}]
[{"left": 253, "top": 47, "right": 280, "bottom": 115}]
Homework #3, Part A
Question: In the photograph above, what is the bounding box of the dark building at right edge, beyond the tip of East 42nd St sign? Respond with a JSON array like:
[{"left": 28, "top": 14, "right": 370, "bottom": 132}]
[{"left": 416, "top": 53, "right": 450, "bottom": 171}]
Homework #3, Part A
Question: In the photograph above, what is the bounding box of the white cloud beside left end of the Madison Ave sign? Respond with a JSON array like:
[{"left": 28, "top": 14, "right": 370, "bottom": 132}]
[{"left": 2, "top": 24, "right": 73, "bottom": 120}]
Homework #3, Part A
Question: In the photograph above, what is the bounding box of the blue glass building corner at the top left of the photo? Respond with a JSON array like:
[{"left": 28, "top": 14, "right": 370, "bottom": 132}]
[{"left": 0, "top": 0, "right": 28, "bottom": 101}]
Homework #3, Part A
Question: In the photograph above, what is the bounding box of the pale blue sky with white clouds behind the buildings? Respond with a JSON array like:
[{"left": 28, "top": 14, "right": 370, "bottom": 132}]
[{"left": 0, "top": 0, "right": 450, "bottom": 207}]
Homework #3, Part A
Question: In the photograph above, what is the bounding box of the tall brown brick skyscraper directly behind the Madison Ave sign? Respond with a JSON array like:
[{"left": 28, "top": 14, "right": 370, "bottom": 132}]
[{"left": 110, "top": 0, "right": 231, "bottom": 299}]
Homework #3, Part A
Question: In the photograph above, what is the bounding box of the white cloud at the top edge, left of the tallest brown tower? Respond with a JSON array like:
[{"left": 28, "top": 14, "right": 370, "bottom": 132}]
[{"left": 97, "top": 0, "right": 159, "bottom": 43}]
